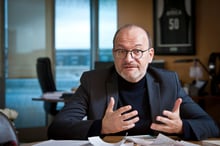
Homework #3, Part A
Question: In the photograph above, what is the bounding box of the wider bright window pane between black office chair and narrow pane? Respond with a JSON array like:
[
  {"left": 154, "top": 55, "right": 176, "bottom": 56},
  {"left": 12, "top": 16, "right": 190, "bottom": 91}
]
[{"left": 55, "top": 0, "right": 90, "bottom": 90}]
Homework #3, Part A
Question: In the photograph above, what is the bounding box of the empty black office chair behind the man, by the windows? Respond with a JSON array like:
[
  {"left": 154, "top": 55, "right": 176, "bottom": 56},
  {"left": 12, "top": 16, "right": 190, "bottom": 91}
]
[{"left": 36, "top": 57, "right": 58, "bottom": 116}]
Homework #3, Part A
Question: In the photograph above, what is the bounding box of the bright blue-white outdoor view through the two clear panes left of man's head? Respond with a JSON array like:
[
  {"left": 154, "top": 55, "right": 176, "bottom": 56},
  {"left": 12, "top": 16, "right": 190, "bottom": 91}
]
[{"left": 55, "top": 0, "right": 117, "bottom": 91}]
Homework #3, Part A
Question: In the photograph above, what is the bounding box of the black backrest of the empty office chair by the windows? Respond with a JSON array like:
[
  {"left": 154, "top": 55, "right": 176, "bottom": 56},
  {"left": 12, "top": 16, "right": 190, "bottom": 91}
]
[{"left": 36, "top": 57, "right": 56, "bottom": 93}]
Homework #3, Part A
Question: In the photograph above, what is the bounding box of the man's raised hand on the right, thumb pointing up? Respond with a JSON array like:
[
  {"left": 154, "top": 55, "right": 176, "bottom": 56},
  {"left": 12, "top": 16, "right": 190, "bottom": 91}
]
[{"left": 151, "top": 98, "right": 183, "bottom": 134}]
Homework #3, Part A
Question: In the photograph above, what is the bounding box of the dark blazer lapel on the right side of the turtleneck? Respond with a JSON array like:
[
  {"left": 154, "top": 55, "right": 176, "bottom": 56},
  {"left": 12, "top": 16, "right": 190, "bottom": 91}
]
[{"left": 146, "top": 73, "right": 161, "bottom": 122}]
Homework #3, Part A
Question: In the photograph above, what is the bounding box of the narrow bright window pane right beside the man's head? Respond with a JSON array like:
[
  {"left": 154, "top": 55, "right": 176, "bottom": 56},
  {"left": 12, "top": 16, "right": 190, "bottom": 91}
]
[{"left": 98, "top": 0, "right": 117, "bottom": 61}]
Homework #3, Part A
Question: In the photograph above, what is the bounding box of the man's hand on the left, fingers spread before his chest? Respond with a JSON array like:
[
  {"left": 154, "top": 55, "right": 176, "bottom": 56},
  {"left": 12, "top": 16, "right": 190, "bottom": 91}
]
[{"left": 101, "top": 97, "right": 139, "bottom": 134}]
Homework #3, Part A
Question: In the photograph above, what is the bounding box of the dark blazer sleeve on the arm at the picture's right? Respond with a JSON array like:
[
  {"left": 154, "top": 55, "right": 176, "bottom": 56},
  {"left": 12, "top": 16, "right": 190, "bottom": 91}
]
[{"left": 175, "top": 74, "right": 219, "bottom": 140}]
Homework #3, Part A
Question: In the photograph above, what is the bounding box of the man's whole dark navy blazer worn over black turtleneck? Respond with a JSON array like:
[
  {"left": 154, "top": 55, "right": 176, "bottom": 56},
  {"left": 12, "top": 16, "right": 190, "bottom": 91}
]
[{"left": 48, "top": 67, "right": 219, "bottom": 140}]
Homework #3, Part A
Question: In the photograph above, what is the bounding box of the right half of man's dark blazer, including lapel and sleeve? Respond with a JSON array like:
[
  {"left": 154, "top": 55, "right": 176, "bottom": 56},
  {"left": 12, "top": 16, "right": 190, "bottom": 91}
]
[{"left": 147, "top": 68, "right": 219, "bottom": 140}]
